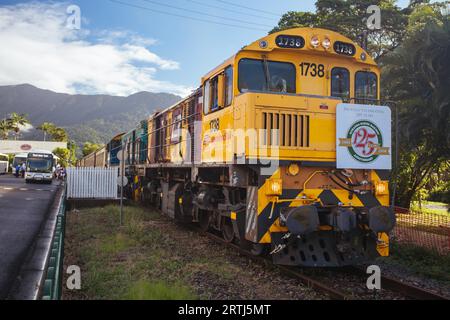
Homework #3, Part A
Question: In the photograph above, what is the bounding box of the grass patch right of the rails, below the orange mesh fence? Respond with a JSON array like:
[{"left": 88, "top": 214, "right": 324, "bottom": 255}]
[{"left": 384, "top": 242, "right": 450, "bottom": 284}]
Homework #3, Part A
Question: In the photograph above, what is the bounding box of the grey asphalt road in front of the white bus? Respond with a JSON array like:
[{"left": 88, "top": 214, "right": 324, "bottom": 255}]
[{"left": 0, "top": 175, "right": 57, "bottom": 299}]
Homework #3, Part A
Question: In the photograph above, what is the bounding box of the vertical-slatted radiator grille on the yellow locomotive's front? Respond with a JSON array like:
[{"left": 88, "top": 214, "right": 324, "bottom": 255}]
[{"left": 261, "top": 112, "right": 310, "bottom": 148}]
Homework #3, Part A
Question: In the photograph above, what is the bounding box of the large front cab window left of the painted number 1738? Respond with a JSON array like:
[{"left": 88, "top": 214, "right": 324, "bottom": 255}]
[{"left": 238, "top": 59, "right": 296, "bottom": 93}]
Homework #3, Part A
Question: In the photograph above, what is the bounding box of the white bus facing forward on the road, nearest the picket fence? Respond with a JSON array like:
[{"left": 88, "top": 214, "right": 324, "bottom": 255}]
[{"left": 25, "top": 151, "right": 55, "bottom": 183}]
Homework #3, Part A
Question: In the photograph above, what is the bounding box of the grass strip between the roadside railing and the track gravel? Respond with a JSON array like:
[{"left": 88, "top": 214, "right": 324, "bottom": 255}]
[{"left": 65, "top": 206, "right": 197, "bottom": 300}]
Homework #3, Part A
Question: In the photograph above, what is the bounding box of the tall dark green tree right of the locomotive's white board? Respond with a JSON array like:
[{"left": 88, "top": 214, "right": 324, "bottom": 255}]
[{"left": 383, "top": 4, "right": 450, "bottom": 207}]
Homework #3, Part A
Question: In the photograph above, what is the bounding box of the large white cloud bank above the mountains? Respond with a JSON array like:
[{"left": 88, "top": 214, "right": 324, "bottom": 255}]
[{"left": 0, "top": 2, "right": 192, "bottom": 96}]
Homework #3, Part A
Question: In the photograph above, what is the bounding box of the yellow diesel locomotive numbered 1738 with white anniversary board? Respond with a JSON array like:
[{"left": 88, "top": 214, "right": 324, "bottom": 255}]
[{"left": 81, "top": 28, "right": 395, "bottom": 266}]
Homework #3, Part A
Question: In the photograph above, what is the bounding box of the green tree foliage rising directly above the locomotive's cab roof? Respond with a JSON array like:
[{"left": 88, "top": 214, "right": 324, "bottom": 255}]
[{"left": 270, "top": 0, "right": 408, "bottom": 59}]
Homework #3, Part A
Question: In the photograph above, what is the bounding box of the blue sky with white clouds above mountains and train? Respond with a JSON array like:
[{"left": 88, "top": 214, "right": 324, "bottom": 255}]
[{"left": 0, "top": 0, "right": 428, "bottom": 95}]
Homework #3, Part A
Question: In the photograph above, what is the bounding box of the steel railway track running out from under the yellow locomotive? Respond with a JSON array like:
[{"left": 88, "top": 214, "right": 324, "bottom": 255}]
[{"left": 197, "top": 226, "right": 449, "bottom": 300}]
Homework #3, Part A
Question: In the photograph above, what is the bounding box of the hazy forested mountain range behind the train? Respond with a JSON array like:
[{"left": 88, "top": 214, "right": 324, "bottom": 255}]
[{"left": 0, "top": 84, "right": 181, "bottom": 151}]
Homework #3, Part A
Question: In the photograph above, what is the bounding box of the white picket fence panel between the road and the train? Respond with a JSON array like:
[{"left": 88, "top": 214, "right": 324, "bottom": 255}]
[{"left": 67, "top": 168, "right": 118, "bottom": 199}]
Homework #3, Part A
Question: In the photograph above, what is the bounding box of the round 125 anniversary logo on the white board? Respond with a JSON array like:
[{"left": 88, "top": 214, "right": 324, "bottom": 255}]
[{"left": 347, "top": 120, "right": 383, "bottom": 163}]
